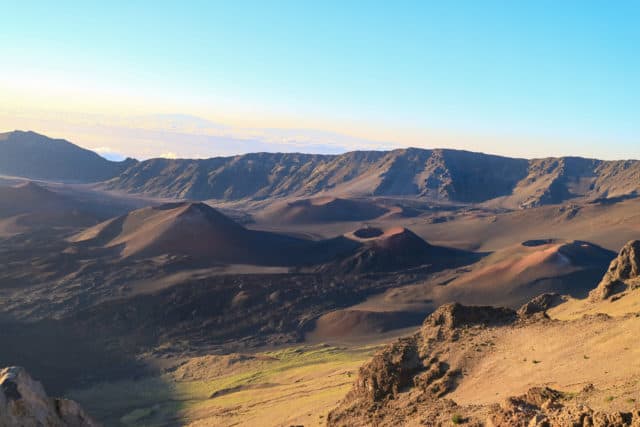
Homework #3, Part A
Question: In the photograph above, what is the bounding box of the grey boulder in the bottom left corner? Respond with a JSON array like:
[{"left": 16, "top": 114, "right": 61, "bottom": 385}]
[{"left": 0, "top": 366, "right": 98, "bottom": 427}]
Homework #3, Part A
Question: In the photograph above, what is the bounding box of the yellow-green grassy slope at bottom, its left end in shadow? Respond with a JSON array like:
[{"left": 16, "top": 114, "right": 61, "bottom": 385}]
[{"left": 69, "top": 345, "right": 375, "bottom": 426}]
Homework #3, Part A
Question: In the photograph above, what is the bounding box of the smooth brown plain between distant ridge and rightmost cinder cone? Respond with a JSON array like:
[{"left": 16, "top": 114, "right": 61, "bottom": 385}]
[{"left": 251, "top": 199, "right": 640, "bottom": 252}]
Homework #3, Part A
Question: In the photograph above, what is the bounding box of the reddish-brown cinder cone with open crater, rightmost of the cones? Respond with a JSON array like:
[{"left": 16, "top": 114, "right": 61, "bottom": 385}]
[{"left": 353, "top": 239, "right": 615, "bottom": 322}]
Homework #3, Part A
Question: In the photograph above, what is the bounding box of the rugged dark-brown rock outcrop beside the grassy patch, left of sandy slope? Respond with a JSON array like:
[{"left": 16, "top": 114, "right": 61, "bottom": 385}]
[{"left": 327, "top": 303, "right": 517, "bottom": 426}]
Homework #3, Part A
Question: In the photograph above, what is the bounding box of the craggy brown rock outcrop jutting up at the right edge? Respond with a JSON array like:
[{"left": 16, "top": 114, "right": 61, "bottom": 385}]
[{"left": 589, "top": 240, "right": 640, "bottom": 301}]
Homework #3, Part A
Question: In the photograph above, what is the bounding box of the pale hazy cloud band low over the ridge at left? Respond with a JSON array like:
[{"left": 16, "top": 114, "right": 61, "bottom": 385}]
[{"left": 0, "top": 111, "right": 397, "bottom": 160}]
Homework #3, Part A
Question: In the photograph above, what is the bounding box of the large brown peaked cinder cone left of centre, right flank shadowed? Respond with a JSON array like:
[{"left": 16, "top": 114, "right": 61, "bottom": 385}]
[{"left": 71, "top": 202, "right": 331, "bottom": 265}]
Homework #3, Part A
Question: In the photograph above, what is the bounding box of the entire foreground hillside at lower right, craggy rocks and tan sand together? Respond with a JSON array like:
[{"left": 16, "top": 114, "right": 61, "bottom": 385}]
[{"left": 328, "top": 242, "right": 640, "bottom": 426}]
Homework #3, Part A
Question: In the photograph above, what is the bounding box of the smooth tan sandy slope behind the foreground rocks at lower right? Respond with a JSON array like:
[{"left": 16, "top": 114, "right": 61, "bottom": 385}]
[{"left": 448, "top": 316, "right": 640, "bottom": 410}]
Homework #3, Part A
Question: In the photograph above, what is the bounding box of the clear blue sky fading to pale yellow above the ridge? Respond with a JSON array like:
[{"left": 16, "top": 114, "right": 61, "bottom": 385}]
[{"left": 0, "top": 0, "right": 640, "bottom": 159}]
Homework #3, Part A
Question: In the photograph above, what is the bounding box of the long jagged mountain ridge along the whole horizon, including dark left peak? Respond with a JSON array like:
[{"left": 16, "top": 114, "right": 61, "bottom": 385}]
[{"left": 0, "top": 132, "right": 640, "bottom": 208}]
